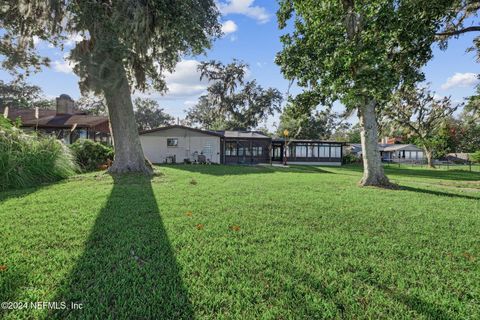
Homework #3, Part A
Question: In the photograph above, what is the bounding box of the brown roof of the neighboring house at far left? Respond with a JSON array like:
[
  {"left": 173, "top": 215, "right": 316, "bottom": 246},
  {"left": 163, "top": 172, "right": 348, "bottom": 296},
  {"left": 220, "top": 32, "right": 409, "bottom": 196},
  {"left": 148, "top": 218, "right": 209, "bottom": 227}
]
[{"left": 2, "top": 109, "right": 108, "bottom": 128}]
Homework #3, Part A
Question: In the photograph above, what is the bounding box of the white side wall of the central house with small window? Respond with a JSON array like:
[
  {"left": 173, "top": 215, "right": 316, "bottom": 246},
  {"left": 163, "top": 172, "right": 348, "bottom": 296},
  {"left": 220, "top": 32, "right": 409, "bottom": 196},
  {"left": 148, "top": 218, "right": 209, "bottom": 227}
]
[{"left": 140, "top": 128, "right": 220, "bottom": 163}]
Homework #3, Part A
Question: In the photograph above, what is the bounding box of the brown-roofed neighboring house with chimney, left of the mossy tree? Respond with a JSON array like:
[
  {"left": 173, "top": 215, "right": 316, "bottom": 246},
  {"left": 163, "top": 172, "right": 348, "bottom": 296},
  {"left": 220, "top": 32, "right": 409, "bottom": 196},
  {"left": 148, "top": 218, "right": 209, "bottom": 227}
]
[{"left": 0, "top": 94, "right": 111, "bottom": 144}]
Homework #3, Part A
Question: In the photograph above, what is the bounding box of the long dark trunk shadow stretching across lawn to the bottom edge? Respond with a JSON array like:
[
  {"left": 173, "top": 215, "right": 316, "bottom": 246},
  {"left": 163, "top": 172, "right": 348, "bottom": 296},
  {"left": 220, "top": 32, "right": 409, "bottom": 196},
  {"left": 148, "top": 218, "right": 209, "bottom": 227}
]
[{"left": 49, "top": 175, "right": 194, "bottom": 319}]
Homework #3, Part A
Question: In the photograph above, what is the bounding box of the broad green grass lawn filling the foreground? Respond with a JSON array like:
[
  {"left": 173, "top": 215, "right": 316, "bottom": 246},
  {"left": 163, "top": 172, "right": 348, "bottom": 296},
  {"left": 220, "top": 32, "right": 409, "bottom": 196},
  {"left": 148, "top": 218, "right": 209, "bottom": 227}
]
[{"left": 0, "top": 166, "right": 480, "bottom": 319}]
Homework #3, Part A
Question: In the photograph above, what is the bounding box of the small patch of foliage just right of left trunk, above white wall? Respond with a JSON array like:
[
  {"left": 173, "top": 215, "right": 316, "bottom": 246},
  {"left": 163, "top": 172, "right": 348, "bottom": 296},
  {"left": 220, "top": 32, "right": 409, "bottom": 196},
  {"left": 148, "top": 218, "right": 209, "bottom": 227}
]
[{"left": 133, "top": 98, "right": 174, "bottom": 131}]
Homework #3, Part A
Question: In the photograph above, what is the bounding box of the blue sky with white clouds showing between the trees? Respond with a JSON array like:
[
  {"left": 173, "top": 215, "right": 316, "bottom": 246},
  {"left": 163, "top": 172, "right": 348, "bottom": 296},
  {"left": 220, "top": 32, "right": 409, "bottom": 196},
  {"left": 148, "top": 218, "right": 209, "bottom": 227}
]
[{"left": 0, "top": 0, "right": 480, "bottom": 130}]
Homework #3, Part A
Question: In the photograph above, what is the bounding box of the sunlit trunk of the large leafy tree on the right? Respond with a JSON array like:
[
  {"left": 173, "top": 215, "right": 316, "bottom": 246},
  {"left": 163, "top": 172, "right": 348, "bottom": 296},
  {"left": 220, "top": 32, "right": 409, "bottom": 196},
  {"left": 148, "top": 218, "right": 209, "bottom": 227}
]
[{"left": 358, "top": 100, "right": 391, "bottom": 187}]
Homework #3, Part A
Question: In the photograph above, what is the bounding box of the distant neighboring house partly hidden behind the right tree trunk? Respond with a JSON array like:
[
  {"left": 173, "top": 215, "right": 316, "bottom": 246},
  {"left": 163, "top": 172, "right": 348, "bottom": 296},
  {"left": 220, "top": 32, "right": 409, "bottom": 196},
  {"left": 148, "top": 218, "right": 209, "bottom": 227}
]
[{"left": 348, "top": 143, "right": 425, "bottom": 162}]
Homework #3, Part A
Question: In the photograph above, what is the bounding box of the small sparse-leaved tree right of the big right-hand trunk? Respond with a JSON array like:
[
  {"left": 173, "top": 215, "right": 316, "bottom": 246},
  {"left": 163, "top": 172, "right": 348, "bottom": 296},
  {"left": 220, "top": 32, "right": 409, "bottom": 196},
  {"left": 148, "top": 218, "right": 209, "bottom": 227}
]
[{"left": 384, "top": 87, "right": 460, "bottom": 168}]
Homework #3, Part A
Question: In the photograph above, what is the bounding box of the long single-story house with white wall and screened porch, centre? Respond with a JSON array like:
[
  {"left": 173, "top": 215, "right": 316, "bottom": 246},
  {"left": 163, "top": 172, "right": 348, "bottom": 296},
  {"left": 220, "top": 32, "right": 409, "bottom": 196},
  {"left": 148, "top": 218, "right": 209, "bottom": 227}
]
[{"left": 140, "top": 125, "right": 343, "bottom": 165}]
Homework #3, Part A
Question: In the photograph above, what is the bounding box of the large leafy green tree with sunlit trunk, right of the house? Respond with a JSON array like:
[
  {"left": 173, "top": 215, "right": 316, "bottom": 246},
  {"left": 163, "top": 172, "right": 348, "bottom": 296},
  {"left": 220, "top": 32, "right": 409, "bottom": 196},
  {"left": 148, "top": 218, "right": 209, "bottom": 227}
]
[{"left": 276, "top": 0, "right": 455, "bottom": 186}]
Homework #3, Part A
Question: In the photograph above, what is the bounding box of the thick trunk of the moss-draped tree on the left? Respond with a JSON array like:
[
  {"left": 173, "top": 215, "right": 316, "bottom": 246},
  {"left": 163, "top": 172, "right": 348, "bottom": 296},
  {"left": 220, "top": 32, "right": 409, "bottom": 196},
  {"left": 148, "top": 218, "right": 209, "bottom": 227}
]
[{"left": 103, "top": 65, "right": 152, "bottom": 174}]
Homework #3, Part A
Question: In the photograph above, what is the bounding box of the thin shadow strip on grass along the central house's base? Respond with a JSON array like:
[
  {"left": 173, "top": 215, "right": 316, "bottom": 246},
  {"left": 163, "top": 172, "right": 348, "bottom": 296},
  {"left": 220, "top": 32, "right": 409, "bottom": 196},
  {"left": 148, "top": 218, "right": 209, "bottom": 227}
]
[{"left": 162, "top": 164, "right": 333, "bottom": 176}]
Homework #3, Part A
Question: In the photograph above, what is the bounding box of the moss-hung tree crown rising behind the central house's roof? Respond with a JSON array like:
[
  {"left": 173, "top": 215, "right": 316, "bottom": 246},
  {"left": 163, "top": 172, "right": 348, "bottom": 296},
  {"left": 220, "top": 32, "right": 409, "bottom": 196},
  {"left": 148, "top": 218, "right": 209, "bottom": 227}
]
[{"left": 186, "top": 60, "right": 282, "bottom": 130}]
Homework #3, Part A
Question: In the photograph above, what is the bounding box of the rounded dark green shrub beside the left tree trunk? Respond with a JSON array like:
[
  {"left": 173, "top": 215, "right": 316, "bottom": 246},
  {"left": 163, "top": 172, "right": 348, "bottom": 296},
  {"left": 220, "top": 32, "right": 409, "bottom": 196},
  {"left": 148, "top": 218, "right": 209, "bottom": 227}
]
[{"left": 70, "top": 139, "right": 113, "bottom": 171}]
